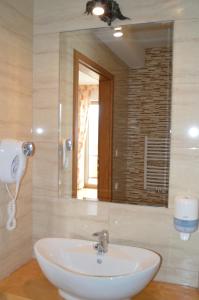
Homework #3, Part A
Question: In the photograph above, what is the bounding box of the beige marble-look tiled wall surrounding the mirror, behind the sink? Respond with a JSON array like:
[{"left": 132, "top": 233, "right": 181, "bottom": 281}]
[{"left": 33, "top": 0, "right": 199, "bottom": 287}]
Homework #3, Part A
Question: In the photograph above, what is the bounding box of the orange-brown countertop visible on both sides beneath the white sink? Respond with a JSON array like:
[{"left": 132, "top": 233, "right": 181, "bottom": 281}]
[{"left": 0, "top": 260, "right": 199, "bottom": 300}]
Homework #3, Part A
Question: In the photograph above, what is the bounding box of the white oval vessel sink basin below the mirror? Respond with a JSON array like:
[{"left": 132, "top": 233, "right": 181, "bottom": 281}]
[{"left": 34, "top": 238, "right": 160, "bottom": 300}]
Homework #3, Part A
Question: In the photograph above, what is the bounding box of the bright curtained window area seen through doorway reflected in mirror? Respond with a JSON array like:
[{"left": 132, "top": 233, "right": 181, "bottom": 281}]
[{"left": 77, "top": 64, "right": 99, "bottom": 199}]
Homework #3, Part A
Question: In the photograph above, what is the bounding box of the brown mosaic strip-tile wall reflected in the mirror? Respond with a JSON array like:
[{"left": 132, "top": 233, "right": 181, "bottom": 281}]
[{"left": 113, "top": 47, "right": 172, "bottom": 206}]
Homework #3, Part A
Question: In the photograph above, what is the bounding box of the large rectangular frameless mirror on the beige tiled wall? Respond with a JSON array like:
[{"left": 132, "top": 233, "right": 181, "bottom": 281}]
[{"left": 59, "top": 22, "right": 173, "bottom": 207}]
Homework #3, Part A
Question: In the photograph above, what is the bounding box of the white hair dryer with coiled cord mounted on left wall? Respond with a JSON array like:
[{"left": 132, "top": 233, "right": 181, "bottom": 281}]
[{"left": 0, "top": 139, "right": 34, "bottom": 230}]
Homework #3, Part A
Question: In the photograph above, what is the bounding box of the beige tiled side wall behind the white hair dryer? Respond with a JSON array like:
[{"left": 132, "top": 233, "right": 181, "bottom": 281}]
[{"left": 0, "top": 0, "right": 33, "bottom": 278}]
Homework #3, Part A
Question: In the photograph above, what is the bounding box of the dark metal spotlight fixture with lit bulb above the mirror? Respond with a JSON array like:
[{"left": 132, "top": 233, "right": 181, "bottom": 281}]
[{"left": 85, "top": 0, "right": 129, "bottom": 26}]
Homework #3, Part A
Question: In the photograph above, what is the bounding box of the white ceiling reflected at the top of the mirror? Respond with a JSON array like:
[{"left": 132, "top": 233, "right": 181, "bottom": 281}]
[{"left": 94, "top": 22, "right": 172, "bottom": 68}]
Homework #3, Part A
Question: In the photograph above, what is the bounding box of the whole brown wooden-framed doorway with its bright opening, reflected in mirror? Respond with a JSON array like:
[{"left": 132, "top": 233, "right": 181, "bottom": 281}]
[{"left": 72, "top": 51, "right": 114, "bottom": 201}]
